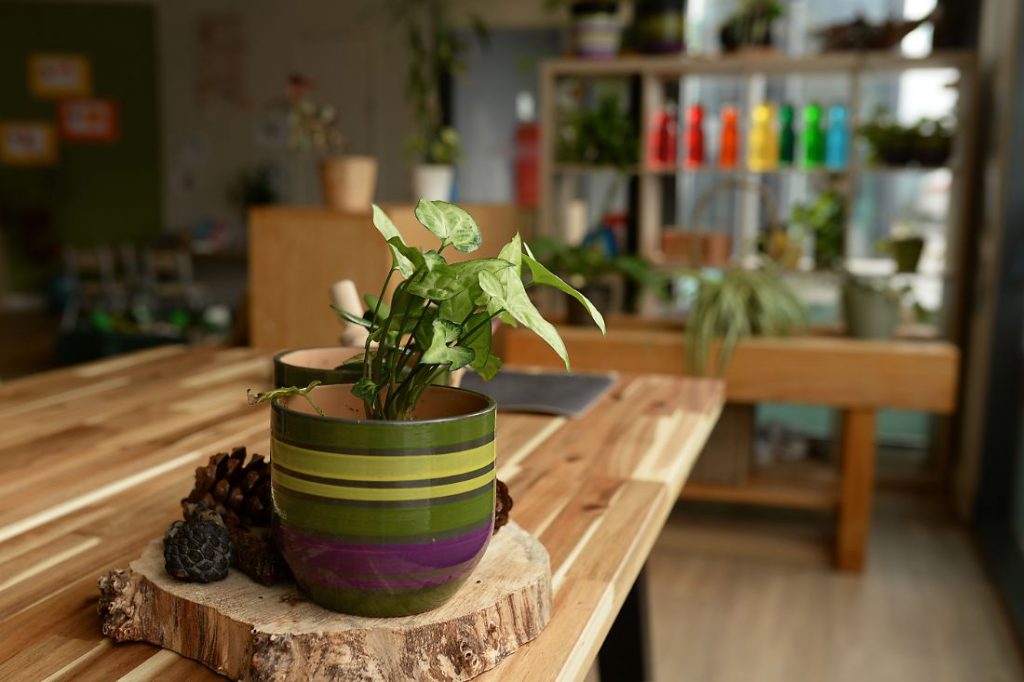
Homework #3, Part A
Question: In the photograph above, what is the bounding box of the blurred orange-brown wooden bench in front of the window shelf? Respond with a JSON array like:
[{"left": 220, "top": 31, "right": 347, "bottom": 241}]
[{"left": 502, "top": 319, "right": 959, "bottom": 571}]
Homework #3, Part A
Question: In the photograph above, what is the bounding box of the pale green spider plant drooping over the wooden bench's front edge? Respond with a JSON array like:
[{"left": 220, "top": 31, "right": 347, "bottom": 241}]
[{"left": 686, "top": 267, "right": 807, "bottom": 375}]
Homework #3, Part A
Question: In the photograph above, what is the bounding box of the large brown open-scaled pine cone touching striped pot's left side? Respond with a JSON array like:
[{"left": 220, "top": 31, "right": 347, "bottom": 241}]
[{"left": 181, "top": 447, "right": 270, "bottom": 526}]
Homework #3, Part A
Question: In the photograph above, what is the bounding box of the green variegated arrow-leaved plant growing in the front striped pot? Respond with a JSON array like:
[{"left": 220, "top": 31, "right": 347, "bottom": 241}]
[{"left": 327, "top": 199, "right": 604, "bottom": 420}]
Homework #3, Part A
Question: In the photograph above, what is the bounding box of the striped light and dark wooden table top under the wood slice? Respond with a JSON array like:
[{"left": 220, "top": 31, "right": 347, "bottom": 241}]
[{"left": 0, "top": 347, "right": 724, "bottom": 680}]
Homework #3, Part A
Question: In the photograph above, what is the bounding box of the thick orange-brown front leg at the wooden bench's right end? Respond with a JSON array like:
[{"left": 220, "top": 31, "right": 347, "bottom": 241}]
[{"left": 836, "top": 409, "right": 874, "bottom": 572}]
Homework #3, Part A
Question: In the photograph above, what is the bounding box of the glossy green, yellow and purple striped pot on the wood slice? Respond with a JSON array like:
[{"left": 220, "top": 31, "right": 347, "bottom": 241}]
[{"left": 271, "top": 385, "right": 495, "bottom": 616}]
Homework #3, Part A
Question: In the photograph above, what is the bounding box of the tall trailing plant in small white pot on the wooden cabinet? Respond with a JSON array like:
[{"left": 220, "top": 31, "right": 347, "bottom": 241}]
[{"left": 382, "top": 0, "right": 488, "bottom": 201}]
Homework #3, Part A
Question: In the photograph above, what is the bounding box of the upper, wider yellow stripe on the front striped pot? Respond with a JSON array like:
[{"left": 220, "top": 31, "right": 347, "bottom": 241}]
[{"left": 270, "top": 439, "right": 495, "bottom": 477}]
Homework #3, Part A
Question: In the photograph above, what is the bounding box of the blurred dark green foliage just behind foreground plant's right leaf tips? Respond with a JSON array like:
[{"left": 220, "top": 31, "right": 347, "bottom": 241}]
[{"left": 531, "top": 237, "right": 667, "bottom": 291}]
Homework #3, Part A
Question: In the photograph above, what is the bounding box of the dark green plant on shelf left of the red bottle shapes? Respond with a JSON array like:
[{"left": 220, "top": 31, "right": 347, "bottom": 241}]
[{"left": 558, "top": 94, "right": 640, "bottom": 170}]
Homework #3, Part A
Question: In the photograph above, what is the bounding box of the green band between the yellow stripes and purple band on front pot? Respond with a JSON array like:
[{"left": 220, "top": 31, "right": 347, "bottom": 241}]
[{"left": 273, "top": 485, "right": 495, "bottom": 544}]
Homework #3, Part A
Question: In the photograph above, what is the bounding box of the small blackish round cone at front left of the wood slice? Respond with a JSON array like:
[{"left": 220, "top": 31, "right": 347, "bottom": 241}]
[{"left": 164, "top": 514, "right": 231, "bottom": 583}]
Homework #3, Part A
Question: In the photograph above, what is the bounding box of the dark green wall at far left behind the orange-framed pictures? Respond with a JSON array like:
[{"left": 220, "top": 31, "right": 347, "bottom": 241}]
[{"left": 0, "top": 2, "right": 162, "bottom": 290}]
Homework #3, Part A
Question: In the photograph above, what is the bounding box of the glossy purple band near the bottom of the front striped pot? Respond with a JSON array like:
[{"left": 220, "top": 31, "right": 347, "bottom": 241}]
[{"left": 276, "top": 524, "right": 492, "bottom": 576}]
